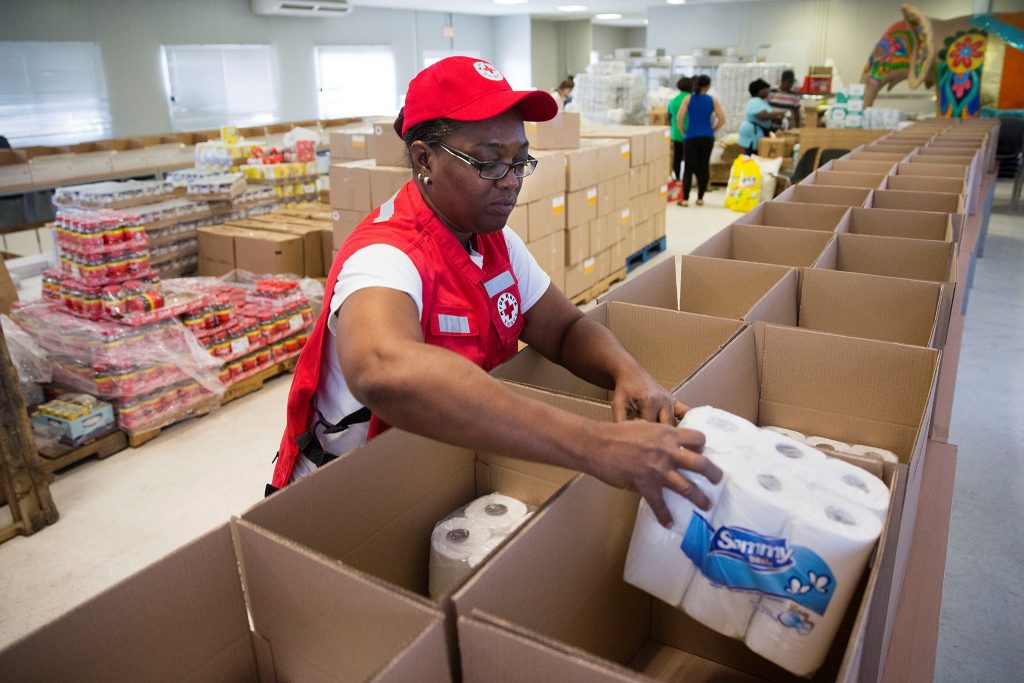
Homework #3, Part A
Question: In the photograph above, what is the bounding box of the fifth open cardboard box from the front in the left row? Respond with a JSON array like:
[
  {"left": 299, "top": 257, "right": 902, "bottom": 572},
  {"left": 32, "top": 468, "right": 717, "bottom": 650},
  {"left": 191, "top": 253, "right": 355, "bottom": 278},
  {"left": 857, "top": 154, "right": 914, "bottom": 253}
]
[{"left": 598, "top": 253, "right": 800, "bottom": 325}]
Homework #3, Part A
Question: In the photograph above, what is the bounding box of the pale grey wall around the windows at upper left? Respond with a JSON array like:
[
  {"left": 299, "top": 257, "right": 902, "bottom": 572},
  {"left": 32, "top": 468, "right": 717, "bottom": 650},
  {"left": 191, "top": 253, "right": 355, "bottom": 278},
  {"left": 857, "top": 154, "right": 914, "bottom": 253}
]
[{"left": 0, "top": 0, "right": 501, "bottom": 136}]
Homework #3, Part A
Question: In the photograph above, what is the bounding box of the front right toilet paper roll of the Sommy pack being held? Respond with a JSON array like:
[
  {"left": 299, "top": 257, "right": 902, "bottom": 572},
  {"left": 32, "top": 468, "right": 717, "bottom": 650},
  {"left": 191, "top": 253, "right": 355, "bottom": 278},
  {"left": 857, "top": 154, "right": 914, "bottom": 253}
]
[{"left": 744, "top": 492, "right": 882, "bottom": 676}]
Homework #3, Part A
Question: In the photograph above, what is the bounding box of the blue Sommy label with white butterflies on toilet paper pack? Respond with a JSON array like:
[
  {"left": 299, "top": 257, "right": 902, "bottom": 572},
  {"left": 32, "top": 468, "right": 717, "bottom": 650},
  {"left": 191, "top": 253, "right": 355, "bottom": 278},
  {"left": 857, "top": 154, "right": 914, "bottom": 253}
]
[{"left": 682, "top": 513, "right": 836, "bottom": 614}]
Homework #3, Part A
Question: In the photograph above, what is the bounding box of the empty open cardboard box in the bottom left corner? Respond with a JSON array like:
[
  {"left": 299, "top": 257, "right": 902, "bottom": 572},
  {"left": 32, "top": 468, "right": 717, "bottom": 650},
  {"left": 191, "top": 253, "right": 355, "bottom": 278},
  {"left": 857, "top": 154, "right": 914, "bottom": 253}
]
[{"left": 0, "top": 521, "right": 451, "bottom": 683}]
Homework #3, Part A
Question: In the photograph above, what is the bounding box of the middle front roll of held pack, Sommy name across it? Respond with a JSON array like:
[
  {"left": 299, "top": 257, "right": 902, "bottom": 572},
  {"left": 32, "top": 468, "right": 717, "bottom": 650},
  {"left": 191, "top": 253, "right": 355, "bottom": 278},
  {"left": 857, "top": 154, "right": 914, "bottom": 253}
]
[{"left": 682, "top": 461, "right": 807, "bottom": 638}]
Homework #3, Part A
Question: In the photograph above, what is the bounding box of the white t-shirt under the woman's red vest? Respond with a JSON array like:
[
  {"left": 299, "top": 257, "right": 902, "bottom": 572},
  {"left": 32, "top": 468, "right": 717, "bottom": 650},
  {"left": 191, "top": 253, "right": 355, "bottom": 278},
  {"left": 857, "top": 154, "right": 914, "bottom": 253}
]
[{"left": 292, "top": 227, "right": 551, "bottom": 481}]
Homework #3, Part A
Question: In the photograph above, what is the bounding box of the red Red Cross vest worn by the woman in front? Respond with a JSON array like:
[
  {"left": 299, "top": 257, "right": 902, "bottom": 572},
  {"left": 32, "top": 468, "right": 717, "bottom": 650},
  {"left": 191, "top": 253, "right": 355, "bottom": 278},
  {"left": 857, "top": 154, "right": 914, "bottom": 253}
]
[{"left": 272, "top": 181, "right": 523, "bottom": 488}]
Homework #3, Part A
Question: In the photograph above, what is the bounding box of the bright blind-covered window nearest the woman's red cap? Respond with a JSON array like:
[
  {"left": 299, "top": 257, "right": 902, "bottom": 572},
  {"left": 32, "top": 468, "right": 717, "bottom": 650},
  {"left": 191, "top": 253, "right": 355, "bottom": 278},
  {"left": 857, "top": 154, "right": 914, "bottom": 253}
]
[{"left": 316, "top": 45, "right": 398, "bottom": 119}]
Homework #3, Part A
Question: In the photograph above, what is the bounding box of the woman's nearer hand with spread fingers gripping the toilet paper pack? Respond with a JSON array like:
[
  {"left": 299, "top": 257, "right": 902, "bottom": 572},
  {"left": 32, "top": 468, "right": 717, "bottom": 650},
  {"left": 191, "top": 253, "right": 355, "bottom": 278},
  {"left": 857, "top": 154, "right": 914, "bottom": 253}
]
[{"left": 587, "top": 420, "right": 722, "bottom": 527}]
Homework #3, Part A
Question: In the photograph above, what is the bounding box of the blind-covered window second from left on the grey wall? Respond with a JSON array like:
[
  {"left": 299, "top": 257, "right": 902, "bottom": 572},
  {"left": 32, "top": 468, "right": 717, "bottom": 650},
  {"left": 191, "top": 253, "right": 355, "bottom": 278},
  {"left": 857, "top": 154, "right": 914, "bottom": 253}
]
[{"left": 162, "top": 45, "right": 279, "bottom": 131}]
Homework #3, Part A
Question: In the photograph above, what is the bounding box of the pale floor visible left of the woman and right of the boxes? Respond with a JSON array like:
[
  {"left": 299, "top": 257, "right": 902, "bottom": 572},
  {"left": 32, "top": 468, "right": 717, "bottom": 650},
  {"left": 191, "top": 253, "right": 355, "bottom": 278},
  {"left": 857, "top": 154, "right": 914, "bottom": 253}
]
[{"left": 0, "top": 181, "right": 1024, "bottom": 681}]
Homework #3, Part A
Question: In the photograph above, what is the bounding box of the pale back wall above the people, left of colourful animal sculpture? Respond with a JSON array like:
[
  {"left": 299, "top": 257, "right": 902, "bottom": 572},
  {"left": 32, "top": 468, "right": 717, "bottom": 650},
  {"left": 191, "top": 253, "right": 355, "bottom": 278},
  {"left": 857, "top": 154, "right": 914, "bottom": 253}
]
[{"left": 646, "top": 0, "right": 991, "bottom": 92}]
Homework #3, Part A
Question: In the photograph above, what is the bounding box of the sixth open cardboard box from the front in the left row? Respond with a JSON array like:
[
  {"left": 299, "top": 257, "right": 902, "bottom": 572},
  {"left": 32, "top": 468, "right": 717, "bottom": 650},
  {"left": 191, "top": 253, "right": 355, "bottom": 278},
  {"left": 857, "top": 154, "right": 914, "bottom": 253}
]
[{"left": 690, "top": 224, "right": 836, "bottom": 266}]
